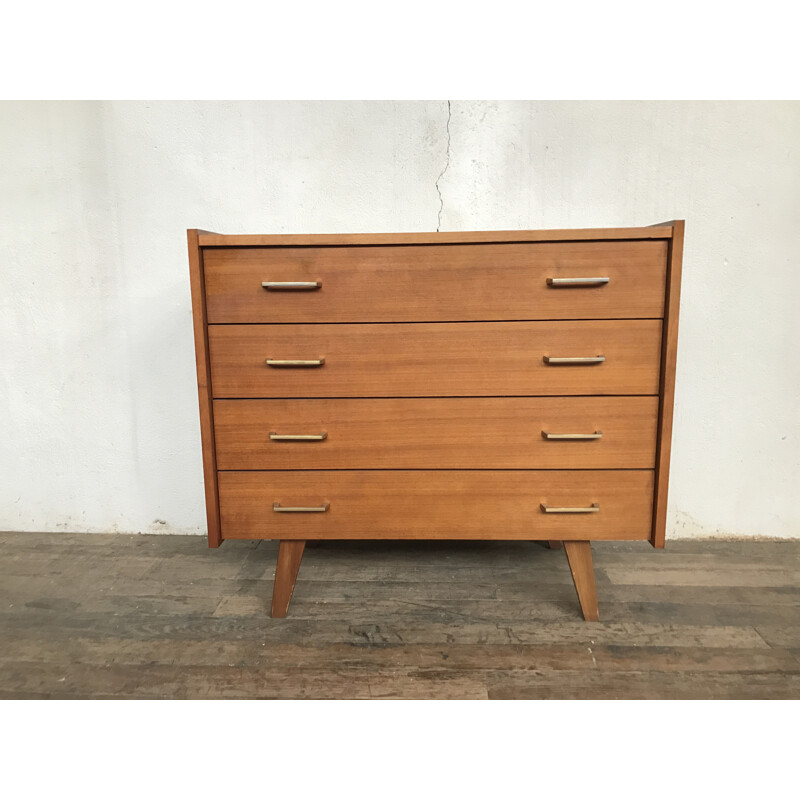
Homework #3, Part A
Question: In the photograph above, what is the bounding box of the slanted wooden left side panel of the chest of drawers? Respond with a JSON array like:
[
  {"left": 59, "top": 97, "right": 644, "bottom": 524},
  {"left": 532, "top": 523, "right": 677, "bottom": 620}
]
[{"left": 187, "top": 230, "right": 222, "bottom": 547}]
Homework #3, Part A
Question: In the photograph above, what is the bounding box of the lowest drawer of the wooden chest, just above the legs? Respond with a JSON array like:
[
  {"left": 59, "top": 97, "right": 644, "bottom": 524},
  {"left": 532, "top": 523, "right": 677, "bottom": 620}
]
[{"left": 219, "top": 470, "right": 653, "bottom": 540}]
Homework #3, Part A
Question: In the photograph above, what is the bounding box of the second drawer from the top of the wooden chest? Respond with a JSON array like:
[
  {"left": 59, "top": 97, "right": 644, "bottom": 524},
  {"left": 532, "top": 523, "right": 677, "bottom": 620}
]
[{"left": 208, "top": 320, "right": 661, "bottom": 398}]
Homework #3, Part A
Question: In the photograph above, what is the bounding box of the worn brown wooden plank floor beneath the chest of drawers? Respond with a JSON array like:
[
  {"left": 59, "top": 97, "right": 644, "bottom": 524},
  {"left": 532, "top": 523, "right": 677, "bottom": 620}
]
[{"left": 0, "top": 533, "right": 800, "bottom": 699}]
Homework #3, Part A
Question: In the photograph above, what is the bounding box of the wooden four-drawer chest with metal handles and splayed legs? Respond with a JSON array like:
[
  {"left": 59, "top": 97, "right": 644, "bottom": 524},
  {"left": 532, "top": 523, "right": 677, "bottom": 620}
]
[{"left": 188, "top": 221, "right": 683, "bottom": 619}]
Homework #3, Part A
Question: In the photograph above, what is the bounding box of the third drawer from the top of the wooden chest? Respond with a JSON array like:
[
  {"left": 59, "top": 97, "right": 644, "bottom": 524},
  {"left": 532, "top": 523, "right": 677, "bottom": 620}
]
[{"left": 214, "top": 397, "right": 658, "bottom": 470}]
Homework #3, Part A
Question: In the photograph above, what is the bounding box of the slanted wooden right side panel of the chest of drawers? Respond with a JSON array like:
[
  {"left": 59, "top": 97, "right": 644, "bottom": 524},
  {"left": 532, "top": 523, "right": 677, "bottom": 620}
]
[{"left": 651, "top": 220, "right": 685, "bottom": 548}]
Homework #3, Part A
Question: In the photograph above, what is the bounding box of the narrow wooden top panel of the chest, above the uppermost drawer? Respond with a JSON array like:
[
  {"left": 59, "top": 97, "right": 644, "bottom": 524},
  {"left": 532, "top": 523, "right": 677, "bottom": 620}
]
[{"left": 192, "top": 222, "right": 675, "bottom": 247}]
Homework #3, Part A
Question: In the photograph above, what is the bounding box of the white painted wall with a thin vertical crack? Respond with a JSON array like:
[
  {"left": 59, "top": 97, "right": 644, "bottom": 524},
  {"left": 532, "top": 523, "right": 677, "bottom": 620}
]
[{"left": 0, "top": 101, "right": 800, "bottom": 537}]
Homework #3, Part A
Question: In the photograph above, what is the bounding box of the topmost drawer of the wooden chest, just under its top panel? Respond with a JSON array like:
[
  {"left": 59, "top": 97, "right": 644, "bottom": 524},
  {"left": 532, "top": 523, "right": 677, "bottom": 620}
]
[{"left": 203, "top": 240, "right": 667, "bottom": 323}]
